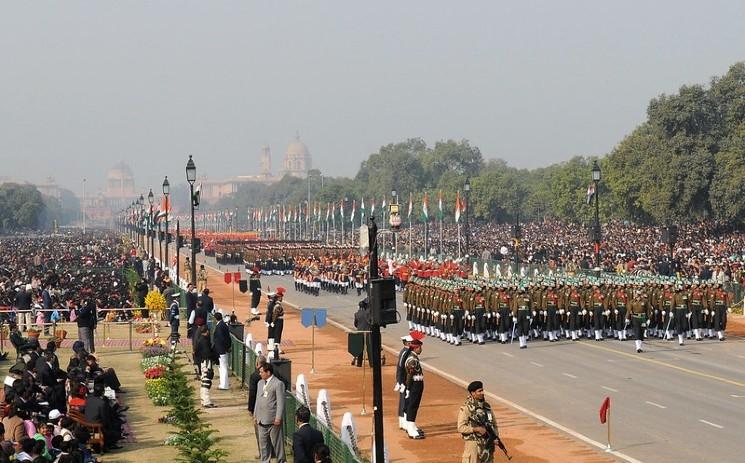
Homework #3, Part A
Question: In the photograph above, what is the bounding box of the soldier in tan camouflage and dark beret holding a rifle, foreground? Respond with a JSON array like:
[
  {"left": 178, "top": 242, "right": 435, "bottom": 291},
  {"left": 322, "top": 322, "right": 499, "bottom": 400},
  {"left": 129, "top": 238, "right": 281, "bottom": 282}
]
[{"left": 458, "top": 381, "right": 498, "bottom": 463}]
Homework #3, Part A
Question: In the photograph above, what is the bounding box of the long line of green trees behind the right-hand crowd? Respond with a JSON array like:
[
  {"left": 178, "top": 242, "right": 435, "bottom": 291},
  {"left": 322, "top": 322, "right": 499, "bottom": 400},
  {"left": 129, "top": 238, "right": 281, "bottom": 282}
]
[{"left": 215, "top": 63, "right": 745, "bottom": 228}]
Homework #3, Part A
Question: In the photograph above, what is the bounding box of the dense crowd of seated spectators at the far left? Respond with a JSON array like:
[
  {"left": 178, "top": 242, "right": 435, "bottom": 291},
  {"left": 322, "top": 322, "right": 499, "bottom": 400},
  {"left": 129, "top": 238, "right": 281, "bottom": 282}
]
[{"left": 0, "top": 232, "right": 131, "bottom": 463}]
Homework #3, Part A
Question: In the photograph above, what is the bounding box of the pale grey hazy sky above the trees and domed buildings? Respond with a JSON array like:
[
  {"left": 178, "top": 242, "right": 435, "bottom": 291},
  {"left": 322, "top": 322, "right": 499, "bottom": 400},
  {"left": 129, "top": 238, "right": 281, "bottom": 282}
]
[{"left": 0, "top": 0, "right": 745, "bottom": 193}]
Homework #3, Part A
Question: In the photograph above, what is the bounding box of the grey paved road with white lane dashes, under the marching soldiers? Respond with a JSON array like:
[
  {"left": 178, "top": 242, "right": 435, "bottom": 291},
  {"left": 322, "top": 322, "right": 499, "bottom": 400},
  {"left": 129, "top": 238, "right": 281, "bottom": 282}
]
[{"left": 253, "top": 276, "right": 745, "bottom": 463}]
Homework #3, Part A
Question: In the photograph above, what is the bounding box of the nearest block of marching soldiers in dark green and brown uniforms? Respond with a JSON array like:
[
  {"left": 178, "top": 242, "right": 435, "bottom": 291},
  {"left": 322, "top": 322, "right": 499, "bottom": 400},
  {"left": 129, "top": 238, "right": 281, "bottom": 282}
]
[{"left": 403, "top": 277, "right": 732, "bottom": 352}]
